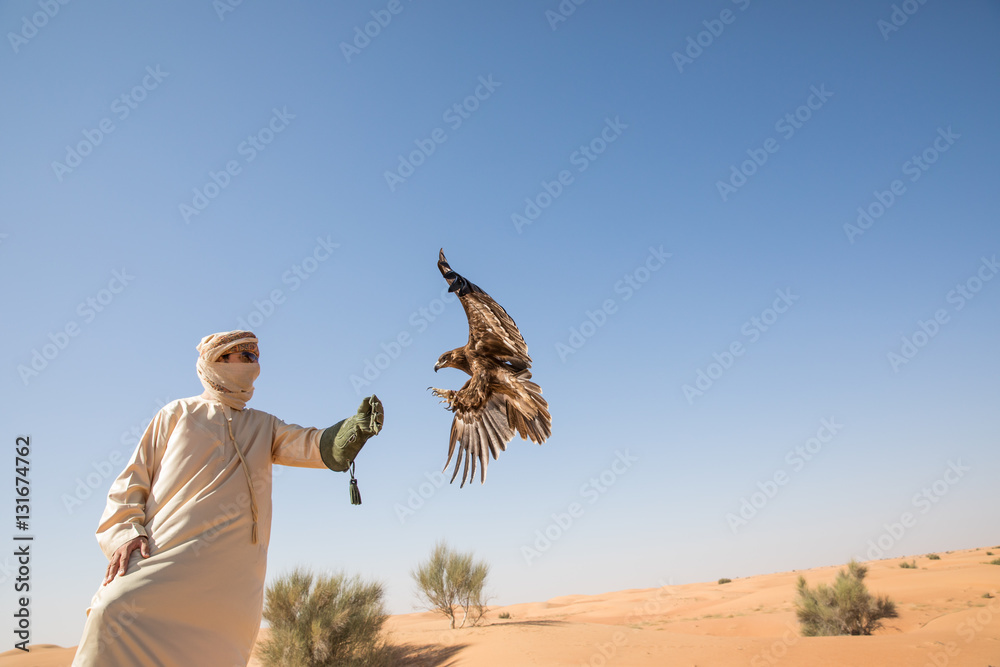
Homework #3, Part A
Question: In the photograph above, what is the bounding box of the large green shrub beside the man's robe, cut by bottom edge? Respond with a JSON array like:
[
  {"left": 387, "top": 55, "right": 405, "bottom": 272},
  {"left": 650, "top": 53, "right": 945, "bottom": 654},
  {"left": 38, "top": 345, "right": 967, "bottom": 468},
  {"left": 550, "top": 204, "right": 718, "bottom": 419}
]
[{"left": 260, "top": 569, "right": 393, "bottom": 667}]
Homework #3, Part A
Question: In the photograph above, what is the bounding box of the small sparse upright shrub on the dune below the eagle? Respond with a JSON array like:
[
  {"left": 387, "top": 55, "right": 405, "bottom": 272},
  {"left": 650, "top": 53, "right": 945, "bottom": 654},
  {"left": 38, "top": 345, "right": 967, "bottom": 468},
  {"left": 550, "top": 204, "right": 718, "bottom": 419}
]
[{"left": 410, "top": 542, "right": 490, "bottom": 629}]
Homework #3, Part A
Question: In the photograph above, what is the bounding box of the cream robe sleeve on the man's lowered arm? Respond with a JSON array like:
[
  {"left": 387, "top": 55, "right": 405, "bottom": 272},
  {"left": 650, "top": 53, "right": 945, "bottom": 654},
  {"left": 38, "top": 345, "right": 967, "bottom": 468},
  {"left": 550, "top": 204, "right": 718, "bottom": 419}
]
[{"left": 97, "top": 410, "right": 171, "bottom": 560}]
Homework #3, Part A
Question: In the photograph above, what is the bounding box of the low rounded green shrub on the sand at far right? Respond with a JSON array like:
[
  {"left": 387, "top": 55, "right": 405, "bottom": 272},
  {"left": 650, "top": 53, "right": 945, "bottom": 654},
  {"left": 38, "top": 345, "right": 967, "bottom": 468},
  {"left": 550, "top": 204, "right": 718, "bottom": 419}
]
[{"left": 795, "top": 560, "right": 899, "bottom": 637}]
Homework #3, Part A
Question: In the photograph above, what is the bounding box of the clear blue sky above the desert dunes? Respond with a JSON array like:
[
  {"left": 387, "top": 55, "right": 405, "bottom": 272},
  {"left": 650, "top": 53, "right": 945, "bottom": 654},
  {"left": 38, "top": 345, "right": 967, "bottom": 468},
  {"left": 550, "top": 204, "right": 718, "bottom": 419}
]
[{"left": 0, "top": 0, "right": 1000, "bottom": 648}]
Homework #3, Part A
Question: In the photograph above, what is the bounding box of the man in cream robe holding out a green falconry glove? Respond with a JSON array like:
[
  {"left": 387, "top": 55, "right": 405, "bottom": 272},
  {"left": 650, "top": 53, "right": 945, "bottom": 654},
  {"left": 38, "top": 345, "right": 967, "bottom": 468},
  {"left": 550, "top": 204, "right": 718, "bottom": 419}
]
[{"left": 73, "top": 331, "right": 383, "bottom": 667}]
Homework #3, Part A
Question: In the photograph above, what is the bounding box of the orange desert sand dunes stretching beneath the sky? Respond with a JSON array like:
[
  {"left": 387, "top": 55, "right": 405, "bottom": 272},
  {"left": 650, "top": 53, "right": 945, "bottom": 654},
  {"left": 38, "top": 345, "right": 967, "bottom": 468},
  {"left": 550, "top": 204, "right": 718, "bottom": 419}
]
[{"left": 0, "top": 547, "right": 1000, "bottom": 667}]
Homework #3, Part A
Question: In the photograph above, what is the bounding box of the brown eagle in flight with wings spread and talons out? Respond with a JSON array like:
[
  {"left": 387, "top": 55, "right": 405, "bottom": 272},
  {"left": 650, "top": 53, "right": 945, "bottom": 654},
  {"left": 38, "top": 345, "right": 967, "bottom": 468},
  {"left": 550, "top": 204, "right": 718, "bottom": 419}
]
[{"left": 429, "top": 249, "right": 552, "bottom": 486}]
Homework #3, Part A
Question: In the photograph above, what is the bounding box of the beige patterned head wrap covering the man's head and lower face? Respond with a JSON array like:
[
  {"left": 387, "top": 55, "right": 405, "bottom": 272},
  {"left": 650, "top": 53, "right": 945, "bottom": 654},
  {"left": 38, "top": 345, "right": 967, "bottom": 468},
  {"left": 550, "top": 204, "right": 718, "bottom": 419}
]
[{"left": 197, "top": 331, "right": 260, "bottom": 410}]
